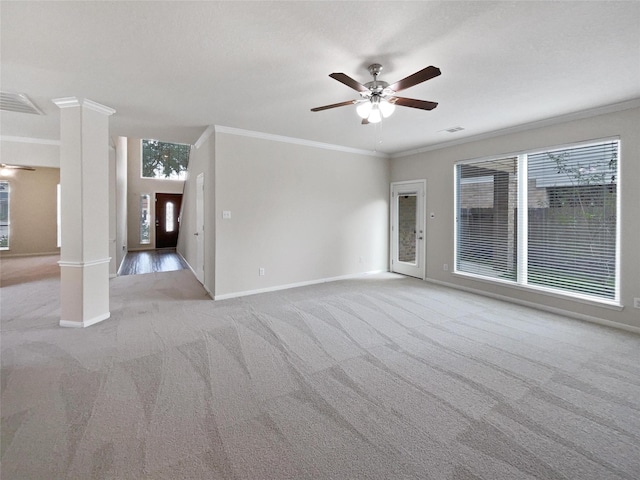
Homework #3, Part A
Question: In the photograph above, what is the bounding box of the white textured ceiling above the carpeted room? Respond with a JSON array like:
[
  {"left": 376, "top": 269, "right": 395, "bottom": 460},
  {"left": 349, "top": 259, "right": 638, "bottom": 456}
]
[{"left": 0, "top": 1, "right": 640, "bottom": 153}]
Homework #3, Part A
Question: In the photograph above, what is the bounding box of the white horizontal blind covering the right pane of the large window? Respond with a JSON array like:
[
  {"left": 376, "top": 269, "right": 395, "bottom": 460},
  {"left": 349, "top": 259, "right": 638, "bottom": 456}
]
[{"left": 527, "top": 141, "right": 618, "bottom": 299}]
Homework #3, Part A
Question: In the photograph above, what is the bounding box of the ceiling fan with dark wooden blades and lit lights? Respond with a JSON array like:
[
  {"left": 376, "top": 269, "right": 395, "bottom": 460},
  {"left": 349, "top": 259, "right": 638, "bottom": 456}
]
[{"left": 311, "top": 63, "right": 441, "bottom": 124}]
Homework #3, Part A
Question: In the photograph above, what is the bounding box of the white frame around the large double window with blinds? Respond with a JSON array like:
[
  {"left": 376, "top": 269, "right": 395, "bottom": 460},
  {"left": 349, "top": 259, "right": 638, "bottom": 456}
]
[{"left": 452, "top": 136, "right": 622, "bottom": 309}]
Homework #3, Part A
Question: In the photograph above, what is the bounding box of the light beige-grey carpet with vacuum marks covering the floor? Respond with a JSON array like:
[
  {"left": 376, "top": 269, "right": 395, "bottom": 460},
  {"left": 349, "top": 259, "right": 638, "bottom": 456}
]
[{"left": 0, "top": 253, "right": 640, "bottom": 480}]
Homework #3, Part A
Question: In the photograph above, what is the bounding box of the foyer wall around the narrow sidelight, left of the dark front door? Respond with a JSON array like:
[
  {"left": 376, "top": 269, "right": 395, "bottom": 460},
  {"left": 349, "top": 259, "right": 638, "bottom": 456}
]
[{"left": 127, "top": 138, "right": 184, "bottom": 250}]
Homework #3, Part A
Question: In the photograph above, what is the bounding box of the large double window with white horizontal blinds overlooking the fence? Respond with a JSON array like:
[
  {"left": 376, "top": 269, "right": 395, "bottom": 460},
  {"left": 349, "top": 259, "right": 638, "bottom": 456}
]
[{"left": 455, "top": 140, "right": 619, "bottom": 300}]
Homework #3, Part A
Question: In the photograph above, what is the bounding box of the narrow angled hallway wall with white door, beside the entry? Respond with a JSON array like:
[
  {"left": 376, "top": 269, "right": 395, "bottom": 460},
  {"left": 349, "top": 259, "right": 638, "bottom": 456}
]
[{"left": 177, "top": 130, "right": 216, "bottom": 294}]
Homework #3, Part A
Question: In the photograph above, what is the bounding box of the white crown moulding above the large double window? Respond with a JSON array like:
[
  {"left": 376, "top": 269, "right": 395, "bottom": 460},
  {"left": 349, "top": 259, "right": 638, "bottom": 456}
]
[{"left": 389, "top": 98, "right": 640, "bottom": 159}]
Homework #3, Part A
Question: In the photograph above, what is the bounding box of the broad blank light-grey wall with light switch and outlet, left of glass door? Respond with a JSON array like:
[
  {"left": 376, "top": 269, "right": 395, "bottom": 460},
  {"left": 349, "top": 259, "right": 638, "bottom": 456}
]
[{"left": 214, "top": 132, "right": 389, "bottom": 298}]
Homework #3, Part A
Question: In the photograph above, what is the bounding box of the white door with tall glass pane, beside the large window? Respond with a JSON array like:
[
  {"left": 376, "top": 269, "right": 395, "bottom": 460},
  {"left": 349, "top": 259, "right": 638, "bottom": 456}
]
[{"left": 390, "top": 180, "right": 427, "bottom": 279}]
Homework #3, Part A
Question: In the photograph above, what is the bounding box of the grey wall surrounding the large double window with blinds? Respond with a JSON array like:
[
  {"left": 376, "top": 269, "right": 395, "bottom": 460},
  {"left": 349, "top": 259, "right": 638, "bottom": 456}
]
[{"left": 391, "top": 108, "right": 640, "bottom": 328}]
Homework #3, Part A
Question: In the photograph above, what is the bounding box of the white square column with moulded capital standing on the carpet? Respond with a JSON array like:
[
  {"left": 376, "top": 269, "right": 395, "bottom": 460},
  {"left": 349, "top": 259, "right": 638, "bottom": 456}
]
[{"left": 53, "top": 97, "right": 115, "bottom": 327}]
